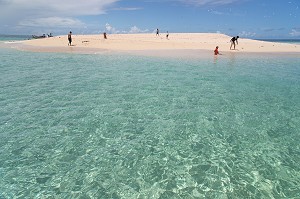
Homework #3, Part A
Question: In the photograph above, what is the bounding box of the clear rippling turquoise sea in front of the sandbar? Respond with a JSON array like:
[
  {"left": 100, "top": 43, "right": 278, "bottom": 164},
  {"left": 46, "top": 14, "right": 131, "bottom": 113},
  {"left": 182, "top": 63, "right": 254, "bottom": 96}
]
[{"left": 0, "top": 36, "right": 300, "bottom": 199}]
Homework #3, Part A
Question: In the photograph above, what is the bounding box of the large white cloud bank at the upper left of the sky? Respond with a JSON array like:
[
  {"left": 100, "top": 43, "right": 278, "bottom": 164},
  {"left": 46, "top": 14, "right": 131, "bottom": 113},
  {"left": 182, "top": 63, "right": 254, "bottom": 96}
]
[{"left": 0, "top": 0, "right": 120, "bottom": 31}]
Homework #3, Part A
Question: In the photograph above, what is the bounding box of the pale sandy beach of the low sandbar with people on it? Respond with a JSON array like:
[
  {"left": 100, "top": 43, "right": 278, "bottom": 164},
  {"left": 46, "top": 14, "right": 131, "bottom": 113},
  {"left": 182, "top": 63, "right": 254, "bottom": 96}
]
[{"left": 15, "top": 33, "right": 300, "bottom": 55}]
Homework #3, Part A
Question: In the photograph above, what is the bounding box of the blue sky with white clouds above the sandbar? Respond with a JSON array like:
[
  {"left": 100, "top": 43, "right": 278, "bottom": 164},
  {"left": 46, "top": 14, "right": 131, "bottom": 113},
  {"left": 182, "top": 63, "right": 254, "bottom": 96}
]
[{"left": 0, "top": 0, "right": 300, "bottom": 39}]
